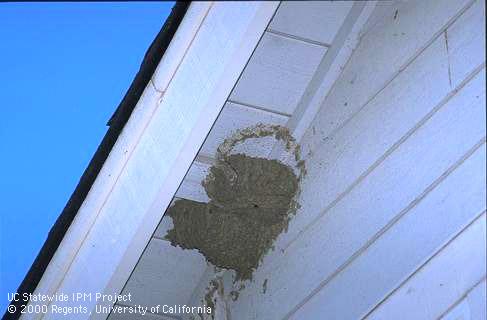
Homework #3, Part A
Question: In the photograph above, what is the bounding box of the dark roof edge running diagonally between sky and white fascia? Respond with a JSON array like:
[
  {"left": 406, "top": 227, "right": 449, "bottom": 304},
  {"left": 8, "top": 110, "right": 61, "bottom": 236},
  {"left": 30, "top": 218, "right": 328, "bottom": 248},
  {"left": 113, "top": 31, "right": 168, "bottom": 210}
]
[{"left": 2, "top": 2, "right": 190, "bottom": 320}]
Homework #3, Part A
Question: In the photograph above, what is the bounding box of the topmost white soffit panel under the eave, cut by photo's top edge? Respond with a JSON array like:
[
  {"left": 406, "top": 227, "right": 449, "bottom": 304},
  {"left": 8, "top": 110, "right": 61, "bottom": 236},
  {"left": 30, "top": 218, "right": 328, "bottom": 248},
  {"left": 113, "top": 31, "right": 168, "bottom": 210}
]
[{"left": 269, "top": 1, "right": 353, "bottom": 44}]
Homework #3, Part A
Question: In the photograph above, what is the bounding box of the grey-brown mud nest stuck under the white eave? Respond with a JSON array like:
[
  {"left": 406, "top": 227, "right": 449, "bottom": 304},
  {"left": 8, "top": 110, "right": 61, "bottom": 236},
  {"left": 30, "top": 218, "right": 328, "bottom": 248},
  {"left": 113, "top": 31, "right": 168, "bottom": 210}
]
[{"left": 166, "top": 154, "right": 298, "bottom": 279}]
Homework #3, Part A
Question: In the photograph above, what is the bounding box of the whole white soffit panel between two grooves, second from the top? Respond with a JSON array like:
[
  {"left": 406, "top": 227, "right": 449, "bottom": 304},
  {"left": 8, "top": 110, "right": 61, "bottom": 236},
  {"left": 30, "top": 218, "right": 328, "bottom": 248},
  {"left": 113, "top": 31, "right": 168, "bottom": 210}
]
[{"left": 230, "top": 32, "right": 326, "bottom": 115}]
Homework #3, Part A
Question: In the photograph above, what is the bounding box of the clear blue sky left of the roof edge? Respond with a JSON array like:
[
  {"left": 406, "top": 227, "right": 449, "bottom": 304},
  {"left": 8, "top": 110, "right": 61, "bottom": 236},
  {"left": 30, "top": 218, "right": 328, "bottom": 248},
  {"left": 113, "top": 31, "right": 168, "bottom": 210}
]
[{"left": 0, "top": 2, "right": 173, "bottom": 315}]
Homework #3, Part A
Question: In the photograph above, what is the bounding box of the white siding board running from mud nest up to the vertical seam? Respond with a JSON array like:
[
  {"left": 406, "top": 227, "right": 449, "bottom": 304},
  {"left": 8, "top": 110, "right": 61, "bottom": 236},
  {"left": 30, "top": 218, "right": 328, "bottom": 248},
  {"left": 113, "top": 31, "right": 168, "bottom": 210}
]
[{"left": 282, "top": 34, "right": 450, "bottom": 247}]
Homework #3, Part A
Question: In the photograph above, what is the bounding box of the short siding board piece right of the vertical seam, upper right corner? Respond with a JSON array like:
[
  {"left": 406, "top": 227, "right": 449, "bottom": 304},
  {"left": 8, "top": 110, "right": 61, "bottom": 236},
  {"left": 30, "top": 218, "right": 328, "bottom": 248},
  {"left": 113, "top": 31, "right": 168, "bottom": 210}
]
[{"left": 446, "top": 0, "right": 485, "bottom": 86}]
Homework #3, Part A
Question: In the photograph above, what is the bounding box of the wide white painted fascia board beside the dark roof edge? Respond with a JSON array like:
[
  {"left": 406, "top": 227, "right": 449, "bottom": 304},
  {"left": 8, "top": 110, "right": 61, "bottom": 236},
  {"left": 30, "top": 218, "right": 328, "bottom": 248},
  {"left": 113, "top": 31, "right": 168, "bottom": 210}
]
[{"left": 22, "top": 2, "right": 279, "bottom": 319}]
